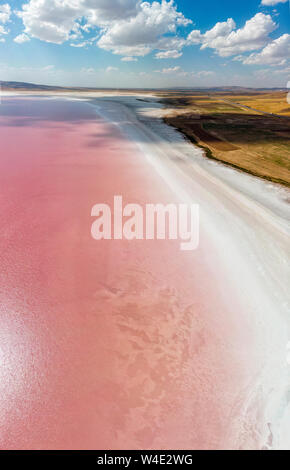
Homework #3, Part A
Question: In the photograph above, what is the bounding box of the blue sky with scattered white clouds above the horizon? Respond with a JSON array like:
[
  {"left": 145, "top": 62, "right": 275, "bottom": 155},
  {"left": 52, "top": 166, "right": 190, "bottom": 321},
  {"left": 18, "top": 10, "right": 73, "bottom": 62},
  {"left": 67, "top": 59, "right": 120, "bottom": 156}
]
[{"left": 0, "top": 0, "right": 290, "bottom": 87}]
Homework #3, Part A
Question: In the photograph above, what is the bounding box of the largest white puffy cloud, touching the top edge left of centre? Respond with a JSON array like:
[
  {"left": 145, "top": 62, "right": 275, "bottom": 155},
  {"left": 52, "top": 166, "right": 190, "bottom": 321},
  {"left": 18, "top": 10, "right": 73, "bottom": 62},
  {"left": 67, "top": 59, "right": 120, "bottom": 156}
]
[{"left": 17, "top": 0, "right": 191, "bottom": 57}]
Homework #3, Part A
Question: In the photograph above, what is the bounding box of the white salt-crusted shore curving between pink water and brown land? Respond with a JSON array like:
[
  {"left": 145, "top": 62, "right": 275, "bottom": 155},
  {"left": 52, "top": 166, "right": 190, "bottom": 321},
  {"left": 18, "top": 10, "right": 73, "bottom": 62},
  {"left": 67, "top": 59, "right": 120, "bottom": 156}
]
[{"left": 87, "top": 93, "right": 290, "bottom": 448}]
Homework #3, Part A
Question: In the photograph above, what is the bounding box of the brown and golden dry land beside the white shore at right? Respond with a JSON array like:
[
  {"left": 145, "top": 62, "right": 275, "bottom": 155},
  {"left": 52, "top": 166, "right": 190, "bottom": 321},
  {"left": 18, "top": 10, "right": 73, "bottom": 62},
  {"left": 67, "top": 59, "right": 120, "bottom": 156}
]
[{"left": 160, "top": 92, "right": 290, "bottom": 187}]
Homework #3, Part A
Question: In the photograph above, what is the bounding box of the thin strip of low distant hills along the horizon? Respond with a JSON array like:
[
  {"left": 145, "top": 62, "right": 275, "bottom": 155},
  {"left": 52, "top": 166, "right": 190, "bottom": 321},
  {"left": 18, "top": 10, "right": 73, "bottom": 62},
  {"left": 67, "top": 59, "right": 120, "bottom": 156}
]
[{"left": 0, "top": 80, "right": 289, "bottom": 93}]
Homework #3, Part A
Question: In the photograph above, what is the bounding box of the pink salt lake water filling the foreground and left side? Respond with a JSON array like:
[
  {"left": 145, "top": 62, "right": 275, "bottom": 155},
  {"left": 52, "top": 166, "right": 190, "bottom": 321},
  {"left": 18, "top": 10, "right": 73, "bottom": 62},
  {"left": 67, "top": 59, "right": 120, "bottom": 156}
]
[{"left": 0, "top": 97, "right": 251, "bottom": 449}]
